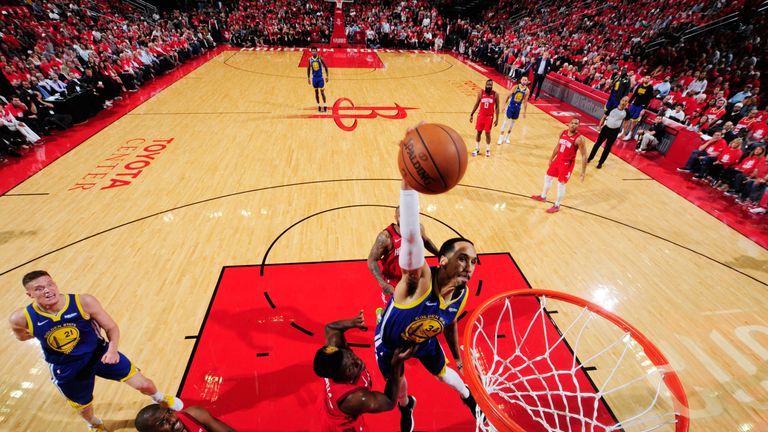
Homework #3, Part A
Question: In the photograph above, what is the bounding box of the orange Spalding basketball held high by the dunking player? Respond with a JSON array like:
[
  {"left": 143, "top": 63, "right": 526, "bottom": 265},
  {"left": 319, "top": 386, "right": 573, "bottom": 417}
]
[{"left": 397, "top": 123, "right": 467, "bottom": 195}]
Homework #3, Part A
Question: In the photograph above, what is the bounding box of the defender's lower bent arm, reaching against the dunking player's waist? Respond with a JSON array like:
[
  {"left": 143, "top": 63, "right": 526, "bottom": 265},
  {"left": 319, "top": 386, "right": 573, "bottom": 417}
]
[{"left": 339, "top": 347, "right": 413, "bottom": 416}]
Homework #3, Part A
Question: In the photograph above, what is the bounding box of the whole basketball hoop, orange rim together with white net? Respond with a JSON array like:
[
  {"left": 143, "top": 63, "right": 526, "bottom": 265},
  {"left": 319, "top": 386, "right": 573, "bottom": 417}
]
[{"left": 461, "top": 289, "right": 689, "bottom": 432}]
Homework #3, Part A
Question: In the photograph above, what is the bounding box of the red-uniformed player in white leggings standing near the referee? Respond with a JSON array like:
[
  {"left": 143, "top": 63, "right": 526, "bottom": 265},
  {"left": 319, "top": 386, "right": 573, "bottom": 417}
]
[{"left": 531, "top": 118, "right": 587, "bottom": 213}]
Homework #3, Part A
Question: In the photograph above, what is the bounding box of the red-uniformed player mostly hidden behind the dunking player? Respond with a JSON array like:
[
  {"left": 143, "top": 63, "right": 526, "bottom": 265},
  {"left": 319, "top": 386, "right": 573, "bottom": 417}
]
[{"left": 368, "top": 206, "right": 438, "bottom": 303}]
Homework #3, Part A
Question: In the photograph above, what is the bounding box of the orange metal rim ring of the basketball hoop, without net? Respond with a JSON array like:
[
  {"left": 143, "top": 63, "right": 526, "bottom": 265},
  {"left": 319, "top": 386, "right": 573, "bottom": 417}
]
[{"left": 461, "top": 289, "right": 690, "bottom": 432}]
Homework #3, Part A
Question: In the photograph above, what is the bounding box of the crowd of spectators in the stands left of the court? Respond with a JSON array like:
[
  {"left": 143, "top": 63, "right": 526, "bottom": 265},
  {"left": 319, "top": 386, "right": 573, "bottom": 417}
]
[{"left": 0, "top": 0, "right": 223, "bottom": 159}]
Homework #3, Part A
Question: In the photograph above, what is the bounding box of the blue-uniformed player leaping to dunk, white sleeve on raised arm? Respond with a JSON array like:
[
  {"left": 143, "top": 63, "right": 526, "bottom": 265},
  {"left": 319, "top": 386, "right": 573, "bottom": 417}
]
[{"left": 373, "top": 182, "right": 477, "bottom": 431}]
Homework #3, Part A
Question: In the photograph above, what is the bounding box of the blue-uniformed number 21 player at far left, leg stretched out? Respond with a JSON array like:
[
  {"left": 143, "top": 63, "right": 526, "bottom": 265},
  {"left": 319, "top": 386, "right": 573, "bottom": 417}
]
[{"left": 10, "top": 270, "right": 184, "bottom": 431}]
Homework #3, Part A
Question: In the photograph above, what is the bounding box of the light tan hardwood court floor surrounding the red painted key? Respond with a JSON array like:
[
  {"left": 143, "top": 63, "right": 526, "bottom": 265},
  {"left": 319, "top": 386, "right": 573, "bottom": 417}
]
[{"left": 0, "top": 52, "right": 768, "bottom": 431}]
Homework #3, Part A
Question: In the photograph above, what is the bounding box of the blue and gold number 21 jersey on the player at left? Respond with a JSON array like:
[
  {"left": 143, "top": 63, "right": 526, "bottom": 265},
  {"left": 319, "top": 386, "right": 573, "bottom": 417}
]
[{"left": 24, "top": 294, "right": 103, "bottom": 365}]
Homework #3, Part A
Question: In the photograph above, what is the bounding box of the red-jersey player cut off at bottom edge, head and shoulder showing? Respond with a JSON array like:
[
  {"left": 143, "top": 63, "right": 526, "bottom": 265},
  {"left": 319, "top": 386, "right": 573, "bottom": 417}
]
[{"left": 134, "top": 404, "right": 235, "bottom": 432}]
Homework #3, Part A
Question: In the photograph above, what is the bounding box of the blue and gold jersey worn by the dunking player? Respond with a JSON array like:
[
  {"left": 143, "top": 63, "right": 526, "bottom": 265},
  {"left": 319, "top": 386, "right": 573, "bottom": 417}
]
[{"left": 375, "top": 267, "right": 468, "bottom": 349}]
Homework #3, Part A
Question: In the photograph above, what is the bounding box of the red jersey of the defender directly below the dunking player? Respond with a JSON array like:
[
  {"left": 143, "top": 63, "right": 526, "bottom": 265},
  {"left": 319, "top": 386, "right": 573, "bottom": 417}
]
[{"left": 321, "top": 367, "right": 373, "bottom": 432}]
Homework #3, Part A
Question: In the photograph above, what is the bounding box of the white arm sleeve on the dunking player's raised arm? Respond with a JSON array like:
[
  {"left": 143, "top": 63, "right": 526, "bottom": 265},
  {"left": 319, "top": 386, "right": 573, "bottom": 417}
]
[{"left": 399, "top": 188, "right": 424, "bottom": 271}]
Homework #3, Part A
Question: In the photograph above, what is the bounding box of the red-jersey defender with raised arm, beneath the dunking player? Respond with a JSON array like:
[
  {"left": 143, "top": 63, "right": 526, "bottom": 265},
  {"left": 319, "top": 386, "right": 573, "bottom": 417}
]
[{"left": 313, "top": 311, "right": 413, "bottom": 432}]
